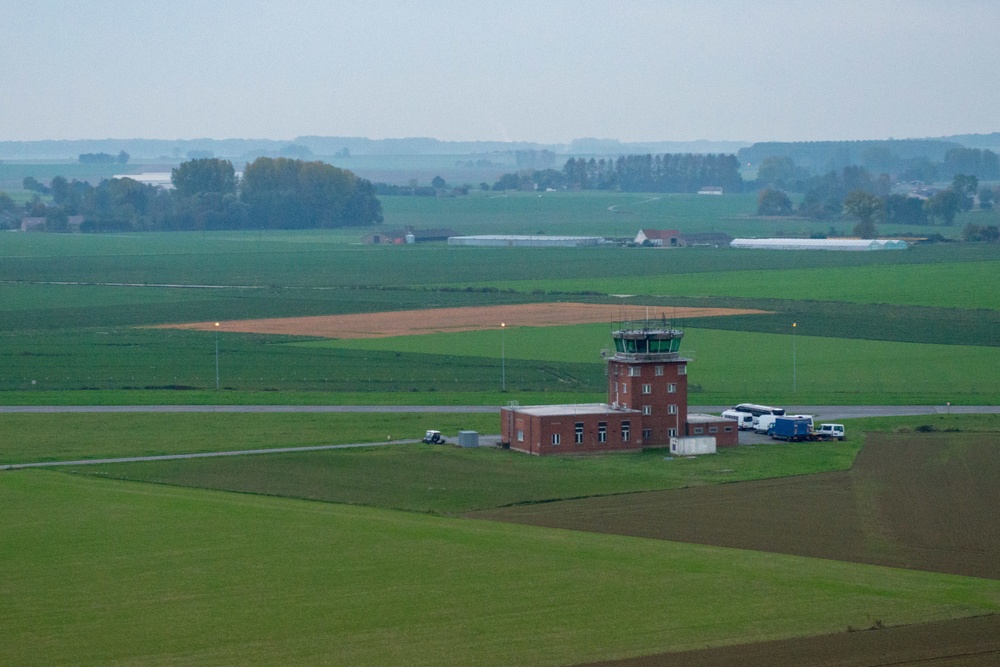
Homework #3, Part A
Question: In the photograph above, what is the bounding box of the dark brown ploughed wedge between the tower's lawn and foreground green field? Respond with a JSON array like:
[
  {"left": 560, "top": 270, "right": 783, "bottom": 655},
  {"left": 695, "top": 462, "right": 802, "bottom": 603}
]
[{"left": 469, "top": 434, "right": 1000, "bottom": 579}]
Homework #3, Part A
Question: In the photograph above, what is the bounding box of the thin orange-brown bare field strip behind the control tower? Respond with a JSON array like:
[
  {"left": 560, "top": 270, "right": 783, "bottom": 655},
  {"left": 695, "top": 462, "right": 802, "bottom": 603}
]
[{"left": 160, "top": 303, "right": 765, "bottom": 338}]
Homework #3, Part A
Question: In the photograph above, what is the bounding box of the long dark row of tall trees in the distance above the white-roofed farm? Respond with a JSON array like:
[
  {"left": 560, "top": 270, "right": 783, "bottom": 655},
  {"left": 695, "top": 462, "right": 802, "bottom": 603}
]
[{"left": 493, "top": 153, "right": 743, "bottom": 192}]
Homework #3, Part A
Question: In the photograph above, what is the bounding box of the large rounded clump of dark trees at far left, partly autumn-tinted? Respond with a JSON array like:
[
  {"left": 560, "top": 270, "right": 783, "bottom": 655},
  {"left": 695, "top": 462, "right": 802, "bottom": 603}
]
[{"left": 0, "top": 157, "right": 382, "bottom": 232}]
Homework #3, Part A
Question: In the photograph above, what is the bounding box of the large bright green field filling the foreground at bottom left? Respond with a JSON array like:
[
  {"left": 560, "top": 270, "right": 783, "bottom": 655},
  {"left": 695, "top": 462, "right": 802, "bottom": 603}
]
[{"left": 0, "top": 471, "right": 1000, "bottom": 665}]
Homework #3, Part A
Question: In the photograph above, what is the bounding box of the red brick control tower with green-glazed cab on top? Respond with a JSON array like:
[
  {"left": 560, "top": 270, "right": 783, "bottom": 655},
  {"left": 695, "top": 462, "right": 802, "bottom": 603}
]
[{"left": 607, "top": 320, "right": 689, "bottom": 447}]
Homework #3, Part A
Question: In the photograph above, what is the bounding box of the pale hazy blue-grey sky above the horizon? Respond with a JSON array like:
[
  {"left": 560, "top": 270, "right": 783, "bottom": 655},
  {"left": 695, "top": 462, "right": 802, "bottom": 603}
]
[{"left": 0, "top": 0, "right": 1000, "bottom": 143}]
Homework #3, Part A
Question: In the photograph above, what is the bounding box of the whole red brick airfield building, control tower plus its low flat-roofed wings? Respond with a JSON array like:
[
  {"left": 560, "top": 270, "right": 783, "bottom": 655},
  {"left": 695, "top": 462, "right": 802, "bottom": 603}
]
[{"left": 500, "top": 322, "right": 739, "bottom": 455}]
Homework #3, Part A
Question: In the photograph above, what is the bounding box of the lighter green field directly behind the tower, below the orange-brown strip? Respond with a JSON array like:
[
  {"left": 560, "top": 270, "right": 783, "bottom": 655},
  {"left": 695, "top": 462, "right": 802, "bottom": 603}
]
[{"left": 307, "top": 322, "right": 1000, "bottom": 405}]
